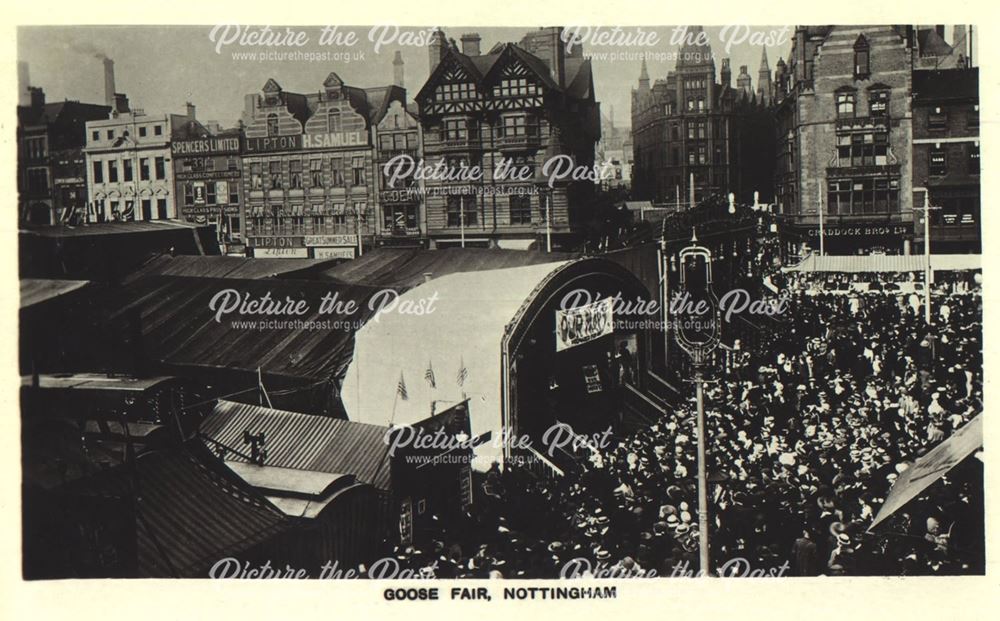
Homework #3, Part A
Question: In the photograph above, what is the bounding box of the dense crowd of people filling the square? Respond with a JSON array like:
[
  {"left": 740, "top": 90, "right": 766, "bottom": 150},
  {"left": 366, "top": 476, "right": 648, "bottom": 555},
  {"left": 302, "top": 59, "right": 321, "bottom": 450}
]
[{"left": 382, "top": 237, "right": 985, "bottom": 578}]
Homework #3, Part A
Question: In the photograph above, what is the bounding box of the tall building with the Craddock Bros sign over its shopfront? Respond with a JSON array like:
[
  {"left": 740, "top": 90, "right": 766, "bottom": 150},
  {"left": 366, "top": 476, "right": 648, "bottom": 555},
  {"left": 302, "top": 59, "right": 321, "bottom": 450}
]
[{"left": 775, "top": 25, "right": 962, "bottom": 254}]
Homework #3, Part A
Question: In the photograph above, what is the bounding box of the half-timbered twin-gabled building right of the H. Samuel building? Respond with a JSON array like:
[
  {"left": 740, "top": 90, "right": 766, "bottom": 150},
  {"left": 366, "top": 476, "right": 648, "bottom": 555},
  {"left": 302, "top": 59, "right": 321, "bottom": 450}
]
[{"left": 415, "top": 28, "right": 601, "bottom": 248}]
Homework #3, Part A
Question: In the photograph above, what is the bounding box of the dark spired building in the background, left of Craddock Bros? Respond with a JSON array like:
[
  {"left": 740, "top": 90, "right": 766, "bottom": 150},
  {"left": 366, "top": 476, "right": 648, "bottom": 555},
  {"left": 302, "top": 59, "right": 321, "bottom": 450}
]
[{"left": 632, "top": 26, "right": 774, "bottom": 206}]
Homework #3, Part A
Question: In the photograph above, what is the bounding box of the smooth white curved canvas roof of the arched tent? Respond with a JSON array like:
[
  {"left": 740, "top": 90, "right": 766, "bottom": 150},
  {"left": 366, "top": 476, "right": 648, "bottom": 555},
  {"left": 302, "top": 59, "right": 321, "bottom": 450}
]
[{"left": 342, "top": 261, "right": 571, "bottom": 470}]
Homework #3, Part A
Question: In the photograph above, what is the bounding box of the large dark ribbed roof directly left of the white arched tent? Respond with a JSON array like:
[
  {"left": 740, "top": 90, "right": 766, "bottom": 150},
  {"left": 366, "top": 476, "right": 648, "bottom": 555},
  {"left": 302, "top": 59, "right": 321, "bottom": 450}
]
[{"left": 107, "top": 276, "right": 377, "bottom": 380}]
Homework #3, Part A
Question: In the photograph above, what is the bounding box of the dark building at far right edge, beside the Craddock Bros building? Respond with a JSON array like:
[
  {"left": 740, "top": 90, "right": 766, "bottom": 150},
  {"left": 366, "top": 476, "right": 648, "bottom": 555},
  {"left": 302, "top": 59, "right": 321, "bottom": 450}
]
[{"left": 913, "top": 68, "right": 982, "bottom": 253}]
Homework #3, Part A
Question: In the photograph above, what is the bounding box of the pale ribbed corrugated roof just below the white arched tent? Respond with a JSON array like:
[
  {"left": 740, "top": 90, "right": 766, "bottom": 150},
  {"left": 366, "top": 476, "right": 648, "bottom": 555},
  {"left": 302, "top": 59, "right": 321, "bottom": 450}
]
[{"left": 201, "top": 400, "right": 390, "bottom": 491}]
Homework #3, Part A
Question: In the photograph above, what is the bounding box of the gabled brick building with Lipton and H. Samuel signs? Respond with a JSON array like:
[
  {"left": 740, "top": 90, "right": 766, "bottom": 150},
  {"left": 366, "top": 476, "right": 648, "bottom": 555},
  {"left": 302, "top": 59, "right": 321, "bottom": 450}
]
[{"left": 243, "top": 73, "right": 406, "bottom": 258}]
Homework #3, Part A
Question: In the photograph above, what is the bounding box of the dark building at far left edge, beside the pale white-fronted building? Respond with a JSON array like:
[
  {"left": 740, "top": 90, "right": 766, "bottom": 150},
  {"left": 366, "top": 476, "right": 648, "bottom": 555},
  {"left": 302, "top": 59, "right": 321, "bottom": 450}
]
[{"left": 17, "top": 87, "right": 111, "bottom": 224}]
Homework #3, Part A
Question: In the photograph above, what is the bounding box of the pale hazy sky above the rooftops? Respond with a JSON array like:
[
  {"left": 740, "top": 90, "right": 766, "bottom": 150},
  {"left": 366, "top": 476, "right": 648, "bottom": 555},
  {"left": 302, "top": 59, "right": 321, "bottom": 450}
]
[{"left": 17, "top": 25, "right": 976, "bottom": 126}]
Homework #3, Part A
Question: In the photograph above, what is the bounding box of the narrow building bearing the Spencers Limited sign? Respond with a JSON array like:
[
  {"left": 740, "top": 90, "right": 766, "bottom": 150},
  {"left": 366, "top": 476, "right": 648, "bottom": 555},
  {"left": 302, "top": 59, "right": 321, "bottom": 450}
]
[{"left": 170, "top": 121, "right": 244, "bottom": 252}]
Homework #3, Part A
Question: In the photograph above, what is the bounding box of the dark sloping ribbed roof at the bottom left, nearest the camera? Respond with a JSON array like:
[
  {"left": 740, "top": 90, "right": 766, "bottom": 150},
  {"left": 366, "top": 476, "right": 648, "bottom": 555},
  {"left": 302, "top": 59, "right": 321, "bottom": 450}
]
[{"left": 67, "top": 451, "right": 289, "bottom": 578}]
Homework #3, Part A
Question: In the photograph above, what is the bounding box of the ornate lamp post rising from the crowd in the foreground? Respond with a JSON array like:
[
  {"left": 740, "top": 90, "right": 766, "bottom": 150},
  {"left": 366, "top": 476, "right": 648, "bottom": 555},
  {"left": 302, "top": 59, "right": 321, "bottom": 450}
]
[{"left": 674, "top": 231, "right": 720, "bottom": 576}]
